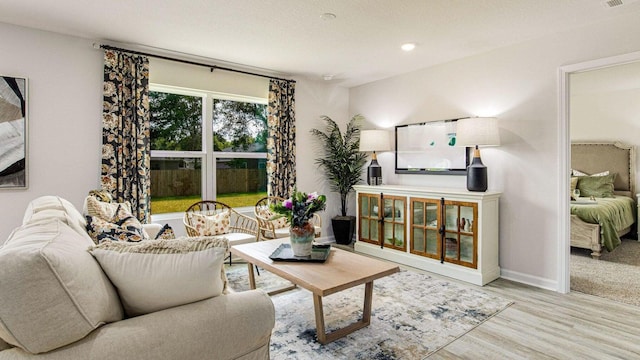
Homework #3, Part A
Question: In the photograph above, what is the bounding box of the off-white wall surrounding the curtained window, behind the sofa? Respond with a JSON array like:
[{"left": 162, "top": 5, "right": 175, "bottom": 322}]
[{"left": 0, "top": 23, "right": 349, "bottom": 243}]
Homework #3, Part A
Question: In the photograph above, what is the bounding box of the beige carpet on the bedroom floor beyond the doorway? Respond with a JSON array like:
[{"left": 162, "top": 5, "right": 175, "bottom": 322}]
[{"left": 570, "top": 239, "right": 640, "bottom": 306}]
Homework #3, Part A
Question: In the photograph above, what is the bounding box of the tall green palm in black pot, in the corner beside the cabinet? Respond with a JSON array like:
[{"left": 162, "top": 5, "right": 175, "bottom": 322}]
[{"left": 311, "top": 115, "right": 366, "bottom": 244}]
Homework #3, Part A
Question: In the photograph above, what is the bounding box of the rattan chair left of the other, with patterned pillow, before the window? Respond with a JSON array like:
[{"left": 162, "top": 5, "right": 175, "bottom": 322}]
[{"left": 183, "top": 200, "right": 258, "bottom": 262}]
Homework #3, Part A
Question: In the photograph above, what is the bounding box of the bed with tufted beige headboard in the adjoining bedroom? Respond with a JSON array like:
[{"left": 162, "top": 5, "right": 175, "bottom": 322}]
[{"left": 571, "top": 142, "right": 637, "bottom": 259}]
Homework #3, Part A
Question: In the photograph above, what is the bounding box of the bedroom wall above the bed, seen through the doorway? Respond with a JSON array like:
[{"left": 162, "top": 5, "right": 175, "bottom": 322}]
[{"left": 569, "top": 62, "right": 640, "bottom": 189}]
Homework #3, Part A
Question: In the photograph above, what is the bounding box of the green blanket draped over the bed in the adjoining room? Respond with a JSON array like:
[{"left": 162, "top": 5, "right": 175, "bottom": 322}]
[{"left": 571, "top": 195, "right": 636, "bottom": 251}]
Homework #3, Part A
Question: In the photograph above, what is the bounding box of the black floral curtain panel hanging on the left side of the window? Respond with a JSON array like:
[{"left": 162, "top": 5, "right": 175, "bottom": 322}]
[{"left": 101, "top": 50, "right": 151, "bottom": 223}]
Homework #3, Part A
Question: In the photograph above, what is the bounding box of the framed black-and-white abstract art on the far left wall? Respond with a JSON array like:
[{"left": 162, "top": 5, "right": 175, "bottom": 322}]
[{"left": 0, "top": 76, "right": 28, "bottom": 189}]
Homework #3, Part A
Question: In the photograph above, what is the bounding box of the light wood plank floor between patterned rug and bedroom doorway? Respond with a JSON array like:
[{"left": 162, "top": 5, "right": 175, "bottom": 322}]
[{"left": 429, "top": 279, "right": 640, "bottom": 360}]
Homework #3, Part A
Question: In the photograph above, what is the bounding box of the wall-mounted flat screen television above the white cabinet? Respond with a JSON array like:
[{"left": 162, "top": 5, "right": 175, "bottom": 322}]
[{"left": 395, "top": 119, "right": 472, "bottom": 175}]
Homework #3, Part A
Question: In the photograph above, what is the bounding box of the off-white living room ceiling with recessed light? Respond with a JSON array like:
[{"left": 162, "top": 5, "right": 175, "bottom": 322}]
[{"left": 0, "top": 0, "right": 640, "bottom": 87}]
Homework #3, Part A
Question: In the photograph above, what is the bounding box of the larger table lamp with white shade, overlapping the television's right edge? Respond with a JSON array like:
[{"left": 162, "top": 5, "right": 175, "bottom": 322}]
[{"left": 456, "top": 117, "right": 500, "bottom": 191}]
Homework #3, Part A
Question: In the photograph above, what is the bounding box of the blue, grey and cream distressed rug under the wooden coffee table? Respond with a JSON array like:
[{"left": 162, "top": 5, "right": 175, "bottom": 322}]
[{"left": 227, "top": 265, "right": 511, "bottom": 360}]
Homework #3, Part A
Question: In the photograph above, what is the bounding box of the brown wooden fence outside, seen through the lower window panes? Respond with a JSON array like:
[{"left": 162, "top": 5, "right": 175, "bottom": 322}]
[{"left": 151, "top": 169, "right": 267, "bottom": 197}]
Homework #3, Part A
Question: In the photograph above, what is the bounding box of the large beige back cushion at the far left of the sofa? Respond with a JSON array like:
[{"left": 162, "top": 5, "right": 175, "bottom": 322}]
[{"left": 0, "top": 220, "right": 123, "bottom": 353}]
